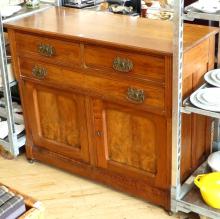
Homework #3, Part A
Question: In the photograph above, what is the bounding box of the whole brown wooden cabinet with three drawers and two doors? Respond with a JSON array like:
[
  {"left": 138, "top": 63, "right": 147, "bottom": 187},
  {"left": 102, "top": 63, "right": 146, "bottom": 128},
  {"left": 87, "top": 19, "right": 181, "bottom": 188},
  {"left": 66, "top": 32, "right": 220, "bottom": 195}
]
[{"left": 6, "top": 8, "right": 217, "bottom": 210}]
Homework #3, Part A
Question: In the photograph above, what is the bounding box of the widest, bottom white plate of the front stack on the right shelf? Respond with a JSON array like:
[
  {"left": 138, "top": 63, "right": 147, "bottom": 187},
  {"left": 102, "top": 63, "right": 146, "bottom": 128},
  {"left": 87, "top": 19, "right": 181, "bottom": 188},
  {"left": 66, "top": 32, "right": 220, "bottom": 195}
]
[{"left": 190, "top": 88, "right": 220, "bottom": 112}]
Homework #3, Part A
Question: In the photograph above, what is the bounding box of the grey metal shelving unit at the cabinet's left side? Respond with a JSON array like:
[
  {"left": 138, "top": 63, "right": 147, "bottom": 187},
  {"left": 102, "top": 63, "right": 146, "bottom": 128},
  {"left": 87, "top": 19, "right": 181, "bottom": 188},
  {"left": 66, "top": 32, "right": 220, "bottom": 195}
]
[{"left": 0, "top": 0, "right": 61, "bottom": 157}]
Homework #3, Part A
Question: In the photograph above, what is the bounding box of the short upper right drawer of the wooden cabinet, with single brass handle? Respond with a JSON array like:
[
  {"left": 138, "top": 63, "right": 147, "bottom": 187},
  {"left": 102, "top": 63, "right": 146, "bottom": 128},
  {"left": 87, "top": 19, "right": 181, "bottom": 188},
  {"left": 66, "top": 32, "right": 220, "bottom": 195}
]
[{"left": 84, "top": 45, "right": 165, "bottom": 82}]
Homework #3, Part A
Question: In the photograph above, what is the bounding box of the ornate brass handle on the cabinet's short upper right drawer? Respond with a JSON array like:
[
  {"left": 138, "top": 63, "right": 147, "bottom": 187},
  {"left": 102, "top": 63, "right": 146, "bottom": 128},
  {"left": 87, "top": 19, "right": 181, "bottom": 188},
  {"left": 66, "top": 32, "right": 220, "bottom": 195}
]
[{"left": 112, "top": 57, "right": 133, "bottom": 72}]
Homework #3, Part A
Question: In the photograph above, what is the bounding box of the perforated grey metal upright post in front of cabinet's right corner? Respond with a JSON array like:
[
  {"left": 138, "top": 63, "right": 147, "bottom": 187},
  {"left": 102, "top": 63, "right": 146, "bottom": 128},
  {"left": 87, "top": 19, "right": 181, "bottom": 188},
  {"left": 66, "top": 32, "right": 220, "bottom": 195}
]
[{"left": 171, "top": 0, "right": 184, "bottom": 212}]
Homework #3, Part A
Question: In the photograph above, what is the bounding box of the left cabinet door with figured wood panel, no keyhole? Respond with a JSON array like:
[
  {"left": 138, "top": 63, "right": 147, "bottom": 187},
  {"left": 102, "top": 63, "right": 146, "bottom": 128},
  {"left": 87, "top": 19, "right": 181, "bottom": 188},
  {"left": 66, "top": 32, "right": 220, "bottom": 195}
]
[{"left": 23, "top": 81, "right": 89, "bottom": 162}]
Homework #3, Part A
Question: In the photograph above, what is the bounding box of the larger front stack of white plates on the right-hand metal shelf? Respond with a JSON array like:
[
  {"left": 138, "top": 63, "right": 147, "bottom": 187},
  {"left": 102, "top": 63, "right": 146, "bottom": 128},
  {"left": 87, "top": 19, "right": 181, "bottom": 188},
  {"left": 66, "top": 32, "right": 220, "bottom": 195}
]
[{"left": 190, "top": 88, "right": 220, "bottom": 112}]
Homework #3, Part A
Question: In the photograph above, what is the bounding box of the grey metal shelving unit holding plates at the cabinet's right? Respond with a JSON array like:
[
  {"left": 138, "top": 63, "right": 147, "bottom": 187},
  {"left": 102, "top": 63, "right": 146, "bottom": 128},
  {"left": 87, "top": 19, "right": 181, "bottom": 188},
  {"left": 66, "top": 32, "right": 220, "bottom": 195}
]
[{"left": 171, "top": 0, "right": 220, "bottom": 219}]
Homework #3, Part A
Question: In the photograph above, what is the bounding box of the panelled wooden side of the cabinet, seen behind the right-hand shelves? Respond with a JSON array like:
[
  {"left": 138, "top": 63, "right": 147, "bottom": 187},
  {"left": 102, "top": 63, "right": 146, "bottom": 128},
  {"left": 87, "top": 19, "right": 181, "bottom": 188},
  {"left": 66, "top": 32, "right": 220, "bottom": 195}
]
[{"left": 181, "top": 36, "right": 215, "bottom": 181}]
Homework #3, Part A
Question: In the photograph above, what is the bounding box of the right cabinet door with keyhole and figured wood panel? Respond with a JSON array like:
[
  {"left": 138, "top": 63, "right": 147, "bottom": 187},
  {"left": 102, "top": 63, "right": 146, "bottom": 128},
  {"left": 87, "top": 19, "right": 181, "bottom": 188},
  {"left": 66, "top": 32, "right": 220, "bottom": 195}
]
[{"left": 93, "top": 100, "right": 171, "bottom": 188}]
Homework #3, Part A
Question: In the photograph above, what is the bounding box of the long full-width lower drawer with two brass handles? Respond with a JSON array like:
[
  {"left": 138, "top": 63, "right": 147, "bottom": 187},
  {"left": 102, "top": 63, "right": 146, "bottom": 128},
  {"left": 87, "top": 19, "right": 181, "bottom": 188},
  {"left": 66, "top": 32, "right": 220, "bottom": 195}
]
[{"left": 20, "top": 59, "right": 165, "bottom": 114}]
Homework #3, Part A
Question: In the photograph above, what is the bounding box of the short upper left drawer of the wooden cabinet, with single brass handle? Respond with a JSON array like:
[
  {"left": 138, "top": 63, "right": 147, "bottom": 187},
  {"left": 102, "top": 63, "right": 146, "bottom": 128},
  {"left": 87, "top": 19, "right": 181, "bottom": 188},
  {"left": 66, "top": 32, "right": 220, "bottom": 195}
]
[{"left": 15, "top": 33, "right": 80, "bottom": 67}]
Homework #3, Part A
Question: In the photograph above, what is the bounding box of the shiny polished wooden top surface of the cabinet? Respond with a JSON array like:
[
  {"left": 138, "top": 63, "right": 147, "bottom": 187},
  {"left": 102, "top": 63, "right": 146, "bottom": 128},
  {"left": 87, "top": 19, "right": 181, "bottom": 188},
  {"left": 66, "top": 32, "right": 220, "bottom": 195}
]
[{"left": 5, "top": 7, "right": 218, "bottom": 54}]
